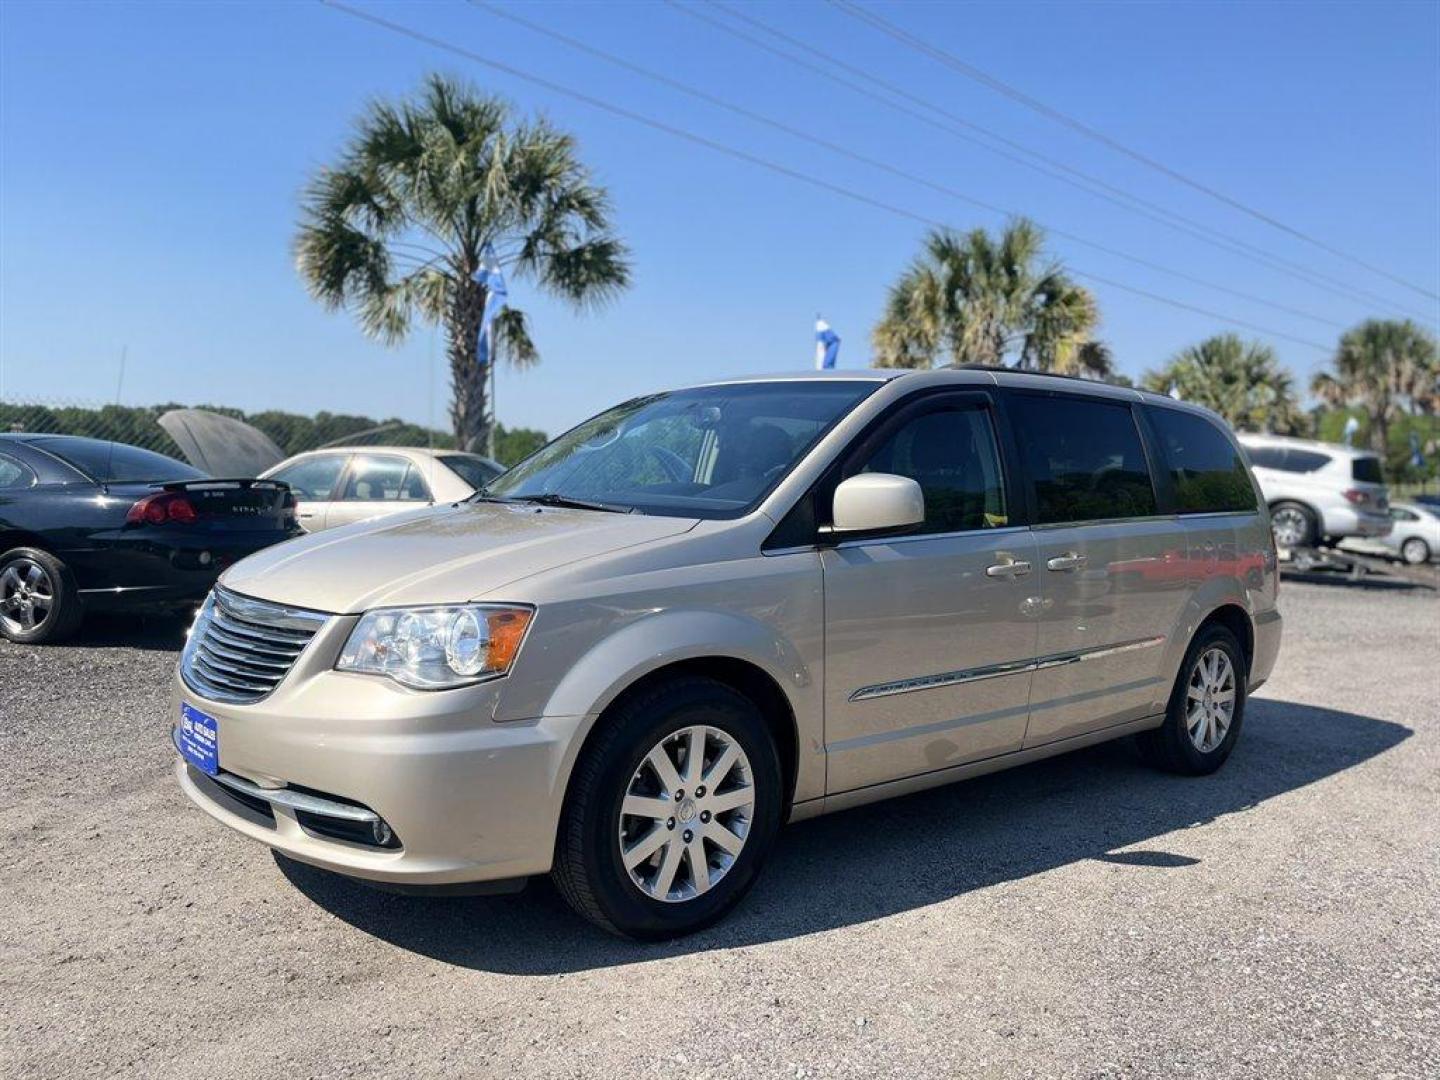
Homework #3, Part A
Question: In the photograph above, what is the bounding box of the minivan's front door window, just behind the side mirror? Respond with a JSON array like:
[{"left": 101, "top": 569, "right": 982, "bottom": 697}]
[{"left": 857, "top": 408, "right": 1009, "bottom": 533}]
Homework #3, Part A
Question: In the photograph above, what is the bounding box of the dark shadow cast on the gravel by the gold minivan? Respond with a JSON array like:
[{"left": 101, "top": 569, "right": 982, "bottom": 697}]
[{"left": 276, "top": 698, "right": 1411, "bottom": 975}]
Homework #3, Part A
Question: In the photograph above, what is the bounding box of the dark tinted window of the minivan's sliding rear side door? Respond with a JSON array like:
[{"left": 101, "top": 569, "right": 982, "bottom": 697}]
[{"left": 1012, "top": 395, "right": 1156, "bottom": 526}]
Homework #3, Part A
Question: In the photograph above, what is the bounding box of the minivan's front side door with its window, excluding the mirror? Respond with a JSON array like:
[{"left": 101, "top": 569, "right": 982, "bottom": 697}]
[{"left": 822, "top": 393, "right": 1040, "bottom": 795}]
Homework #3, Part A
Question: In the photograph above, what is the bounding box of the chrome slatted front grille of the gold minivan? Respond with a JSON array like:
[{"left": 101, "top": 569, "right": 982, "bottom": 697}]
[{"left": 180, "top": 586, "right": 330, "bottom": 704}]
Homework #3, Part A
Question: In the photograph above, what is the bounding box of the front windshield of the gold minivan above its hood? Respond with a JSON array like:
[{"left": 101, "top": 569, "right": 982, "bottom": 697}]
[{"left": 484, "top": 380, "right": 880, "bottom": 517}]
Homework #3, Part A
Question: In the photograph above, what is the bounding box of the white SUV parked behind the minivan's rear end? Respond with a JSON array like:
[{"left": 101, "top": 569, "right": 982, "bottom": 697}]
[{"left": 1240, "top": 435, "right": 1391, "bottom": 547}]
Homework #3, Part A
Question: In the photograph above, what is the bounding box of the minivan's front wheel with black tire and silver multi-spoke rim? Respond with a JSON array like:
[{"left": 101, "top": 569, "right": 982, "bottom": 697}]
[{"left": 552, "top": 677, "right": 783, "bottom": 940}]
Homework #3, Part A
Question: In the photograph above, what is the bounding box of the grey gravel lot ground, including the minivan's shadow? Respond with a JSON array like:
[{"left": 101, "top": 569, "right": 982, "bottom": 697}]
[{"left": 0, "top": 583, "right": 1440, "bottom": 1080}]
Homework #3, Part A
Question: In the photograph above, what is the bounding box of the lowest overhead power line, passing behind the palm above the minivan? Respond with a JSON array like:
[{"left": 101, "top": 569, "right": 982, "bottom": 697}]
[{"left": 318, "top": 0, "right": 1331, "bottom": 353}]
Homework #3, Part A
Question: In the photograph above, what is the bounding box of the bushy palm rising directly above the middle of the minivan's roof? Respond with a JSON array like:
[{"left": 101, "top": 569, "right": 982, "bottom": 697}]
[{"left": 871, "top": 217, "right": 1113, "bottom": 377}]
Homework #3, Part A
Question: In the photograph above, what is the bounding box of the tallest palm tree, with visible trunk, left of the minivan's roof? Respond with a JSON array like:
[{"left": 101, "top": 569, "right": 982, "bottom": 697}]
[{"left": 295, "top": 75, "right": 629, "bottom": 449}]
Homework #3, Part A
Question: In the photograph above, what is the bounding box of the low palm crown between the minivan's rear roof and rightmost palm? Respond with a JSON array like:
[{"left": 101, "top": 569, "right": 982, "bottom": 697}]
[{"left": 1142, "top": 334, "right": 1305, "bottom": 433}]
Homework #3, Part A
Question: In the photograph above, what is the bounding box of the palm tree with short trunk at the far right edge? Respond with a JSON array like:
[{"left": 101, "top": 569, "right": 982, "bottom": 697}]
[{"left": 1310, "top": 318, "right": 1440, "bottom": 454}]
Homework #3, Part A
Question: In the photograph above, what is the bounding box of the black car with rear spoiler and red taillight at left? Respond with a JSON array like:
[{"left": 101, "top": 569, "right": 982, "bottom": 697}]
[{"left": 0, "top": 435, "right": 301, "bottom": 644}]
